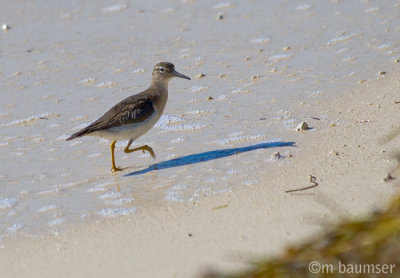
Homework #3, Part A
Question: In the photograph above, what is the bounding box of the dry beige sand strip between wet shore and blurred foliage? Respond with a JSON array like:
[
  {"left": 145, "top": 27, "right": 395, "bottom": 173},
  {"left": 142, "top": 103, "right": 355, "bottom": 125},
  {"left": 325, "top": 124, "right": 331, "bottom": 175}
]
[{"left": 0, "top": 73, "right": 400, "bottom": 277}]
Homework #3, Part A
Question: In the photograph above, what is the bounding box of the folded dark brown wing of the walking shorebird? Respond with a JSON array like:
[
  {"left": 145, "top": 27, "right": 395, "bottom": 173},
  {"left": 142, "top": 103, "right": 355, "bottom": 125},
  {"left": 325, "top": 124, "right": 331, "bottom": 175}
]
[{"left": 67, "top": 95, "right": 155, "bottom": 140}]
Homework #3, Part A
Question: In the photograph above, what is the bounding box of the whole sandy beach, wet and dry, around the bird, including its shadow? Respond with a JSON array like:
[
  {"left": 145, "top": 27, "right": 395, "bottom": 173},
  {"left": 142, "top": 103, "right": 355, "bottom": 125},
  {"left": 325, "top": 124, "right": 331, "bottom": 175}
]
[{"left": 0, "top": 1, "right": 400, "bottom": 277}]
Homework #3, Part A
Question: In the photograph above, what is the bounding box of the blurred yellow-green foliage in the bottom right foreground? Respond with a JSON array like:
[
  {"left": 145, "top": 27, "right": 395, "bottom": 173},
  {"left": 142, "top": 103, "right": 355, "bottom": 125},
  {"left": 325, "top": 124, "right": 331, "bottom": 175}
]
[{"left": 205, "top": 196, "right": 400, "bottom": 278}]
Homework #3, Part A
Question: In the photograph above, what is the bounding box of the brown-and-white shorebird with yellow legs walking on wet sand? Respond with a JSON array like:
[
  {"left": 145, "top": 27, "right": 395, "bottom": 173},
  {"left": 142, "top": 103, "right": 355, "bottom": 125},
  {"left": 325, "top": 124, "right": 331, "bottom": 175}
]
[{"left": 67, "top": 62, "right": 190, "bottom": 172}]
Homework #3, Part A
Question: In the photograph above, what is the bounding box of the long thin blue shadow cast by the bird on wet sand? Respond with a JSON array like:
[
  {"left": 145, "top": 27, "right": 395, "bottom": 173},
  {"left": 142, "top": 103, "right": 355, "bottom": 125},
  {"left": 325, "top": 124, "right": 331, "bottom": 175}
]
[{"left": 125, "top": 142, "right": 295, "bottom": 176}]
